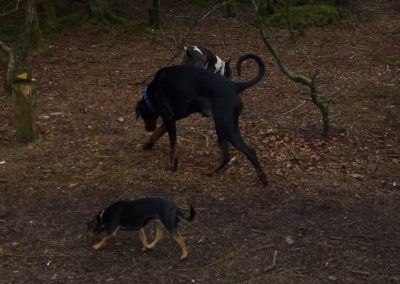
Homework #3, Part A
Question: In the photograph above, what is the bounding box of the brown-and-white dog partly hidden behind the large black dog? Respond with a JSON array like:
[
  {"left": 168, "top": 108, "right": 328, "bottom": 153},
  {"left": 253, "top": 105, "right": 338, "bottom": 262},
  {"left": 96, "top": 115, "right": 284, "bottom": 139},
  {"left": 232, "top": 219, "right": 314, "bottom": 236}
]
[{"left": 182, "top": 45, "right": 232, "bottom": 80}]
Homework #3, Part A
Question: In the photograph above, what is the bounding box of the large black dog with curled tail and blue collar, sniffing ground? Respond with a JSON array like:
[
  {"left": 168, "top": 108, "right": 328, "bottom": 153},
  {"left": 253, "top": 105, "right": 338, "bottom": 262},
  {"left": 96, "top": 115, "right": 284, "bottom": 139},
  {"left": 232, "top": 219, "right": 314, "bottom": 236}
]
[{"left": 136, "top": 54, "right": 268, "bottom": 186}]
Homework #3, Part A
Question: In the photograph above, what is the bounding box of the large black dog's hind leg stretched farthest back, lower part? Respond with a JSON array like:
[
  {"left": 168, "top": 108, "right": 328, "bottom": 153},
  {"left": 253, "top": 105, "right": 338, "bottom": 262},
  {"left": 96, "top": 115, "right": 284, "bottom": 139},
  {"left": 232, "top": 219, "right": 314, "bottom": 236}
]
[{"left": 228, "top": 130, "right": 268, "bottom": 186}]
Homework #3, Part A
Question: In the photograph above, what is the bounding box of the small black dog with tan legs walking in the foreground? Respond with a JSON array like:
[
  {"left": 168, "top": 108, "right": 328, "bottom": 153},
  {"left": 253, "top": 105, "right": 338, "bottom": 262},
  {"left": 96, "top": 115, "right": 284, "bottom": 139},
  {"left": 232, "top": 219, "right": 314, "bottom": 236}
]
[{"left": 88, "top": 197, "right": 196, "bottom": 259}]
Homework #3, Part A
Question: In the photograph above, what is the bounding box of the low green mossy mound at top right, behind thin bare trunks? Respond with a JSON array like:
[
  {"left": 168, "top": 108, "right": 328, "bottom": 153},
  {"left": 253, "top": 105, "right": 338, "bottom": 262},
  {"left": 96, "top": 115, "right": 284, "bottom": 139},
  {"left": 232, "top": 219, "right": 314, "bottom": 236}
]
[{"left": 267, "top": 5, "right": 340, "bottom": 28}]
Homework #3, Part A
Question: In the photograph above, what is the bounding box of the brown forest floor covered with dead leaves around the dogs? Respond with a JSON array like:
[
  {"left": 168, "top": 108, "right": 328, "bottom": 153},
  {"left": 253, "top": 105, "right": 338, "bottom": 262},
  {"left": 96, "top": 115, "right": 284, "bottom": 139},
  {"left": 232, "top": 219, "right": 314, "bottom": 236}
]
[{"left": 0, "top": 1, "right": 400, "bottom": 283}]
